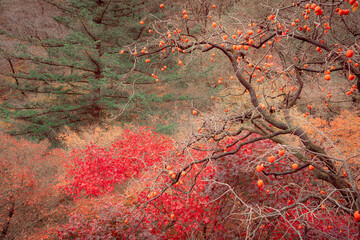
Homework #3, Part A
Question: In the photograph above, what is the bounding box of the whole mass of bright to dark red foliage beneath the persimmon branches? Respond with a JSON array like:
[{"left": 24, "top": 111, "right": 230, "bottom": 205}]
[{"left": 59, "top": 128, "right": 356, "bottom": 239}]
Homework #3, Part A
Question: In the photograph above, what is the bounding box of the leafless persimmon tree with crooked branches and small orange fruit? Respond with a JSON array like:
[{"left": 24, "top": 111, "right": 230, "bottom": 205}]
[{"left": 101, "top": 1, "right": 360, "bottom": 239}]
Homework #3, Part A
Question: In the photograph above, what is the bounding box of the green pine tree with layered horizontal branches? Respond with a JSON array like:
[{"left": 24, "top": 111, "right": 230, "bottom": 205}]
[{"left": 0, "top": 0, "right": 160, "bottom": 142}]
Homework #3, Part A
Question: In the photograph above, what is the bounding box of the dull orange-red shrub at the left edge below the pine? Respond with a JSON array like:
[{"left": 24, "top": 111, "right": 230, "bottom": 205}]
[{"left": 0, "top": 133, "right": 63, "bottom": 239}]
